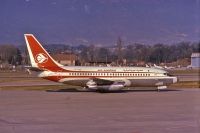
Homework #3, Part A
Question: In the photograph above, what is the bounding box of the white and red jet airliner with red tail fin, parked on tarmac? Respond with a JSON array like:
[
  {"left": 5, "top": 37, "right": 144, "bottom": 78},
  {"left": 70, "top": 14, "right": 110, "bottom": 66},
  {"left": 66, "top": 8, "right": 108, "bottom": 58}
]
[{"left": 24, "top": 34, "right": 177, "bottom": 91}]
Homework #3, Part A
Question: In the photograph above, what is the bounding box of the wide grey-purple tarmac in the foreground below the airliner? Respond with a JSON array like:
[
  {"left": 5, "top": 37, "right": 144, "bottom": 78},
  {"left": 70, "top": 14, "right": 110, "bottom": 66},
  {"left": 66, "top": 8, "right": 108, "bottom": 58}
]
[{"left": 0, "top": 89, "right": 200, "bottom": 133}]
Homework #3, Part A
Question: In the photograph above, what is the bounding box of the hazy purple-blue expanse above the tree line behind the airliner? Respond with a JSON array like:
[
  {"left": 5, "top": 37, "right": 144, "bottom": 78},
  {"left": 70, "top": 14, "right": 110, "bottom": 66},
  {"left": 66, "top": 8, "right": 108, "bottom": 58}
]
[{"left": 0, "top": 0, "right": 200, "bottom": 46}]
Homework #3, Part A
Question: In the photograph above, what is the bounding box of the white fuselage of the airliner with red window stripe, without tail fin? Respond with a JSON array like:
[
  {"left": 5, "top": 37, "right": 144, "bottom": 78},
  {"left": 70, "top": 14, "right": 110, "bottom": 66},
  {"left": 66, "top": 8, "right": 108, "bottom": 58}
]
[{"left": 39, "top": 66, "right": 177, "bottom": 87}]
